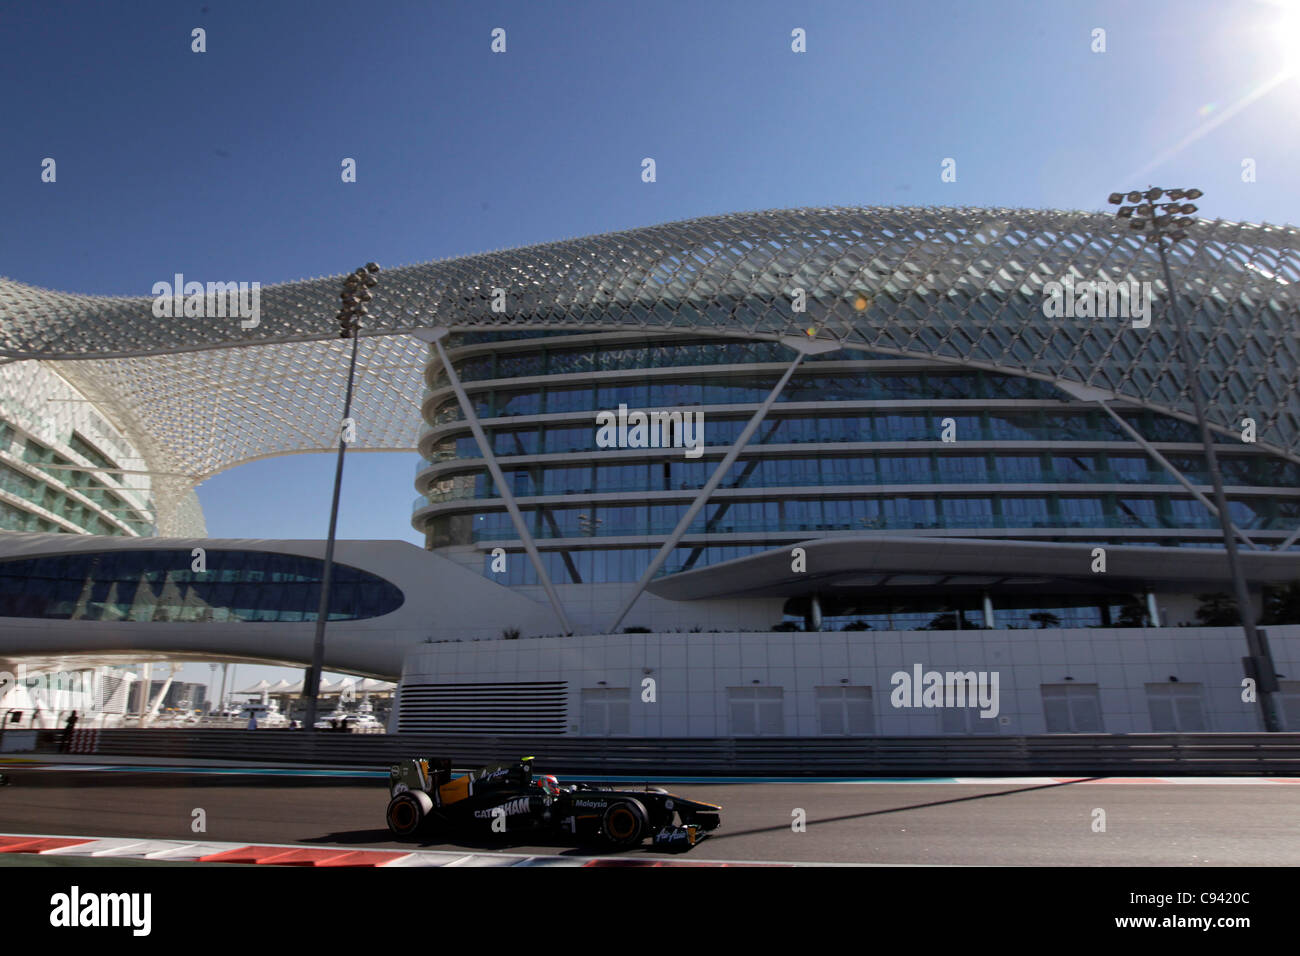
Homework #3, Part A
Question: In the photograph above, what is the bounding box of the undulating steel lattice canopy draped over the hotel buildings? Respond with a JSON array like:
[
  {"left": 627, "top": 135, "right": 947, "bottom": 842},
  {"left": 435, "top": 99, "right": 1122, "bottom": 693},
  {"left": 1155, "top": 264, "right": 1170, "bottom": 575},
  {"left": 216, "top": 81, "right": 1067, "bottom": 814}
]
[{"left": 0, "top": 208, "right": 1300, "bottom": 533}]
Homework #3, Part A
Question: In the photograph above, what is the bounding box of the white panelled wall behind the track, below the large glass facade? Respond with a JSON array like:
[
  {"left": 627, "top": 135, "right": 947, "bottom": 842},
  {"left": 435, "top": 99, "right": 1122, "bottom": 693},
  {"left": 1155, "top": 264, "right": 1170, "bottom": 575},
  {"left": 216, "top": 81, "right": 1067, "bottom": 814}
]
[{"left": 392, "top": 626, "right": 1300, "bottom": 736}]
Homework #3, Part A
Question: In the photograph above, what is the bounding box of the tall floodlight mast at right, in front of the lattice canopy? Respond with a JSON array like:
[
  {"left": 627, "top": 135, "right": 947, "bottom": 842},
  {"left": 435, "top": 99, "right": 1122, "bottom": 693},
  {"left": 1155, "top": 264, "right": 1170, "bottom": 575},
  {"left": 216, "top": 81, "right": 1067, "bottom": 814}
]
[{"left": 1107, "top": 186, "right": 1282, "bottom": 734}]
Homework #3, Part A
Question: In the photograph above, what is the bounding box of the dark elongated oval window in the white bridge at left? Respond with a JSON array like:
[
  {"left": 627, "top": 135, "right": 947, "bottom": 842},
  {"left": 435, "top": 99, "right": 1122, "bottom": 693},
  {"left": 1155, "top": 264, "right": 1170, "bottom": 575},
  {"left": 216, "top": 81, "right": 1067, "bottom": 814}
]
[{"left": 0, "top": 549, "right": 403, "bottom": 622}]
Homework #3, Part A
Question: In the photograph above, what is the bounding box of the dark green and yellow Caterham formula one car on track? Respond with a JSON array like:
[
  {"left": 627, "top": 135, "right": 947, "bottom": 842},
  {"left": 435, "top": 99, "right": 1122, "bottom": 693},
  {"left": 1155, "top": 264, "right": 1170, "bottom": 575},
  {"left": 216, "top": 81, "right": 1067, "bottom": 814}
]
[{"left": 386, "top": 757, "right": 722, "bottom": 851}]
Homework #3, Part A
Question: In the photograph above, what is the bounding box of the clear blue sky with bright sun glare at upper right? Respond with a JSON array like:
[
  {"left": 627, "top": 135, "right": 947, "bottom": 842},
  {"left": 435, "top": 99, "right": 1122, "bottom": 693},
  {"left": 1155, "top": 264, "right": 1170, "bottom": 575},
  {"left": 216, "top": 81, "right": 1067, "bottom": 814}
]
[{"left": 0, "top": 0, "right": 1300, "bottom": 697}]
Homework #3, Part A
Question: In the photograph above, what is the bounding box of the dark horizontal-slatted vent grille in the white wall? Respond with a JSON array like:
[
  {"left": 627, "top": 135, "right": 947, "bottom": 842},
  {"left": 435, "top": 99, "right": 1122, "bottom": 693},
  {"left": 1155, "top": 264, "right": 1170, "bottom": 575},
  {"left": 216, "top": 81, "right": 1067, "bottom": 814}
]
[{"left": 398, "top": 680, "right": 568, "bottom": 734}]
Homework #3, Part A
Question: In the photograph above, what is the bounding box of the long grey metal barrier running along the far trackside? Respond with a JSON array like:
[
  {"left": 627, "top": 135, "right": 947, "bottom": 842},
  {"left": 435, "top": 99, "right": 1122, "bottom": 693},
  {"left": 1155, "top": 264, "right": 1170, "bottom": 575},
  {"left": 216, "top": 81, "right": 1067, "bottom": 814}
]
[{"left": 7, "top": 730, "right": 1300, "bottom": 778}]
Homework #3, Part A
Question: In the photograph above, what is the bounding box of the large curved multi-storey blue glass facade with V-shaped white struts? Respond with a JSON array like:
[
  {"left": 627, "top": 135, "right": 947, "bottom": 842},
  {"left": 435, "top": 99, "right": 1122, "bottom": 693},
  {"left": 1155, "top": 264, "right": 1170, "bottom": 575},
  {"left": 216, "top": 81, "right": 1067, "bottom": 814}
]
[{"left": 415, "top": 333, "right": 1300, "bottom": 584}]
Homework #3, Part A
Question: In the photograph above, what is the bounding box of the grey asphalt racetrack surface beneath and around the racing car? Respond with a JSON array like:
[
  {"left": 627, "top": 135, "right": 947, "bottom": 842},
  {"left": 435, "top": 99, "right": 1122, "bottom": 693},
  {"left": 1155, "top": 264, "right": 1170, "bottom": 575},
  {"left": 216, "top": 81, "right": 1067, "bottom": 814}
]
[{"left": 0, "top": 769, "right": 1300, "bottom": 866}]
